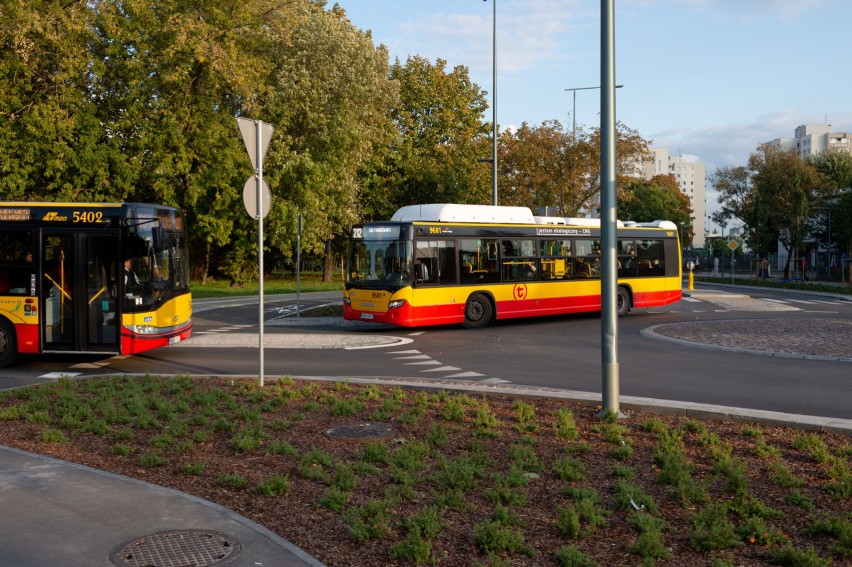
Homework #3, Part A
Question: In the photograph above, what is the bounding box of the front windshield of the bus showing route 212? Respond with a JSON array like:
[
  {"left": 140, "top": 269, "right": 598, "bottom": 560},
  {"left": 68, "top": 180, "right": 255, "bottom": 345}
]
[{"left": 346, "top": 236, "right": 411, "bottom": 289}]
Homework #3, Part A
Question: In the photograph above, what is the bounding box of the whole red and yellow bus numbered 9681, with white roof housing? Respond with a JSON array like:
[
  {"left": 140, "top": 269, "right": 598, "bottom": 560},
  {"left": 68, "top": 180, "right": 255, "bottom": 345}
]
[{"left": 343, "top": 204, "right": 681, "bottom": 328}]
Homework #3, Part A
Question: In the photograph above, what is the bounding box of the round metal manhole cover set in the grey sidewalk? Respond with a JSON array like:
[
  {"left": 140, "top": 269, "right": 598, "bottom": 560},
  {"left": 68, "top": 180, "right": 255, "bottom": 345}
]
[{"left": 110, "top": 530, "right": 240, "bottom": 567}]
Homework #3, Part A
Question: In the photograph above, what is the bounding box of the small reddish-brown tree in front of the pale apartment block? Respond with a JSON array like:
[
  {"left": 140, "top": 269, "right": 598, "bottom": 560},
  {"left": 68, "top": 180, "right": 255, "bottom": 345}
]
[{"left": 618, "top": 175, "right": 695, "bottom": 234}]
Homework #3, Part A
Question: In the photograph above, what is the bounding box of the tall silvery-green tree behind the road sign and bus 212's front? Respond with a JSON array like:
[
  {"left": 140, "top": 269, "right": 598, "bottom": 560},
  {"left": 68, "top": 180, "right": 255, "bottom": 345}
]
[{"left": 264, "top": 5, "right": 397, "bottom": 281}]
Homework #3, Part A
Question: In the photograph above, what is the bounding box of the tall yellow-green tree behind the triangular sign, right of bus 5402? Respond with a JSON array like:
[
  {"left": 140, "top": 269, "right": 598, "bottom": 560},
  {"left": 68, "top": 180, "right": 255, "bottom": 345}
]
[{"left": 92, "top": 0, "right": 297, "bottom": 282}]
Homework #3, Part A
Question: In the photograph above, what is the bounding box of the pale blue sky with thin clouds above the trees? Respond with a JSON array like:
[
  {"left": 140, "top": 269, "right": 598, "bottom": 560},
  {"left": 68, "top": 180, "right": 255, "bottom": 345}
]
[{"left": 336, "top": 0, "right": 852, "bottom": 225}]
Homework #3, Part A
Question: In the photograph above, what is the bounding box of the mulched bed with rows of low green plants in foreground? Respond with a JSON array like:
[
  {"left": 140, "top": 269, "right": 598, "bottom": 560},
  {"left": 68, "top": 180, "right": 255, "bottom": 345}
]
[{"left": 0, "top": 376, "right": 852, "bottom": 566}]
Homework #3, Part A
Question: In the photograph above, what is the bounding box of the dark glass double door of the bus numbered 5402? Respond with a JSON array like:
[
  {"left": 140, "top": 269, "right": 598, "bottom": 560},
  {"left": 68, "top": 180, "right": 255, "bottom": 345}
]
[{"left": 41, "top": 231, "right": 119, "bottom": 352}]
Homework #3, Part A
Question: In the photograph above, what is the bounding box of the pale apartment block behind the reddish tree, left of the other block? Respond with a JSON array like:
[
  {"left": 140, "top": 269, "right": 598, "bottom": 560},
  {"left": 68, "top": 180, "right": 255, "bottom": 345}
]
[{"left": 640, "top": 148, "right": 707, "bottom": 248}]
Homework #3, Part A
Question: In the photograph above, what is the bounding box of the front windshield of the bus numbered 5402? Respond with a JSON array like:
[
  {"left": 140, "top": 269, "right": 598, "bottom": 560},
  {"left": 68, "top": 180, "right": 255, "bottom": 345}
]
[{"left": 123, "top": 207, "right": 189, "bottom": 311}]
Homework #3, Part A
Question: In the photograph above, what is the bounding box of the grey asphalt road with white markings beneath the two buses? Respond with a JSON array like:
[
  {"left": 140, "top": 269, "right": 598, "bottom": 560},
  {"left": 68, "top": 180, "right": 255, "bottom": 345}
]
[{"left": 0, "top": 286, "right": 852, "bottom": 419}]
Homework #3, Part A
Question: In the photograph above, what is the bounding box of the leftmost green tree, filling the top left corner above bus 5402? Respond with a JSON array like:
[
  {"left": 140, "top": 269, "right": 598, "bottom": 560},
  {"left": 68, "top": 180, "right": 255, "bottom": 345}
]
[{"left": 0, "top": 0, "right": 130, "bottom": 201}]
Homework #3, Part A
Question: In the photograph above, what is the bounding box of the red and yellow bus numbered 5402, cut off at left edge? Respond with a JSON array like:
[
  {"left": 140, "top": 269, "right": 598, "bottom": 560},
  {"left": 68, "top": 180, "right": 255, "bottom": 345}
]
[{"left": 0, "top": 201, "right": 192, "bottom": 367}]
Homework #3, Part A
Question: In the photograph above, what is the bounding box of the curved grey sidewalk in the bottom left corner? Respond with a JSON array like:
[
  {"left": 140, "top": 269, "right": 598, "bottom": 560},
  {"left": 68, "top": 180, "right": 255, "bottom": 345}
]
[{"left": 0, "top": 446, "right": 322, "bottom": 567}]
